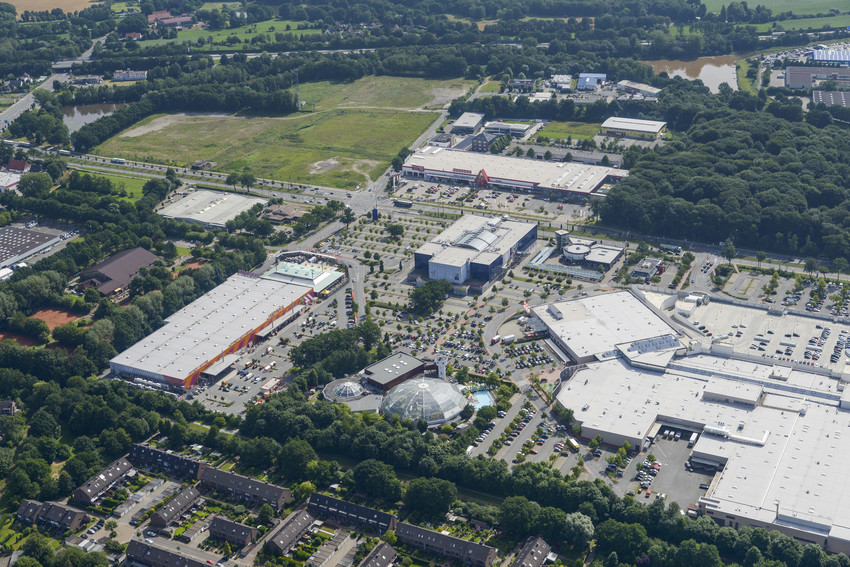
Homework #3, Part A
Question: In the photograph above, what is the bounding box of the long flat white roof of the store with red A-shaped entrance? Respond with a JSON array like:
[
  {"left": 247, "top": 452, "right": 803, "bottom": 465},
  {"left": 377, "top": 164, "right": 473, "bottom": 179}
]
[{"left": 405, "top": 146, "right": 612, "bottom": 194}]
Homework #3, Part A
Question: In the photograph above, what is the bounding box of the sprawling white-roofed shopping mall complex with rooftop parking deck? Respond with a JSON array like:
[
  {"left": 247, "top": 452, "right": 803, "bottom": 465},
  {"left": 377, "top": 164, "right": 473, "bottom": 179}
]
[{"left": 534, "top": 291, "right": 850, "bottom": 553}]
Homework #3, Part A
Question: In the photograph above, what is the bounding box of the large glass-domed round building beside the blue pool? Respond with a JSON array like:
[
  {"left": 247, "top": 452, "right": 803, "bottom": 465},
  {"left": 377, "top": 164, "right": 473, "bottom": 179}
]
[{"left": 381, "top": 378, "right": 468, "bottom": 425}]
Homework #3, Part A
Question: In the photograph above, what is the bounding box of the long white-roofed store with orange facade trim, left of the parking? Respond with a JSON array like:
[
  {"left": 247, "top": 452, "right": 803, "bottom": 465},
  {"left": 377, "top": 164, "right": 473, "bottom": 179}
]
[{"left": 109, "top": 274, "right": 312, "bottom": 391}]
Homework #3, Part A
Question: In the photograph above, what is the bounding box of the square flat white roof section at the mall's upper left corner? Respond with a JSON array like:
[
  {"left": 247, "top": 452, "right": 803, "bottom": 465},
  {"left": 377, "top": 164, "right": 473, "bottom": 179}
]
[{"left": 532, "top": 291, "right": 678, "bottom": 358}]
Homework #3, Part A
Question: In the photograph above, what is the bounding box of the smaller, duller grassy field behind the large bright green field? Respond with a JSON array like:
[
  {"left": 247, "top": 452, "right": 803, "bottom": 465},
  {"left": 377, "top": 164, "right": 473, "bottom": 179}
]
[{"left": 300, "top": 75, "right": 475, "bottom": 110}]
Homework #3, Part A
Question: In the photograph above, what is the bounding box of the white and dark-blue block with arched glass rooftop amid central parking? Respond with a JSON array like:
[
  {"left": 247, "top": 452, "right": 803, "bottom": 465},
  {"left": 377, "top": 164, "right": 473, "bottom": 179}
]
[{"left": 414, "top": 215, "right": 537, "bottom": 287}]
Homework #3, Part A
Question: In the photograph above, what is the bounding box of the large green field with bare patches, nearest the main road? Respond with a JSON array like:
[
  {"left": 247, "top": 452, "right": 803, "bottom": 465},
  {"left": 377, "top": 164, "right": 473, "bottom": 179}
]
[{"left": 95, "top": 109, "right": 436, "bottom": 188}]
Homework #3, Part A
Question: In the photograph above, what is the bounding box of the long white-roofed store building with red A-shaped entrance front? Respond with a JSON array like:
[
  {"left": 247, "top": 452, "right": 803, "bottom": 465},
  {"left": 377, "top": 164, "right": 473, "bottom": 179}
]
[{"left": 402, "top": 146, "right": 627, "bottom": 199}]
